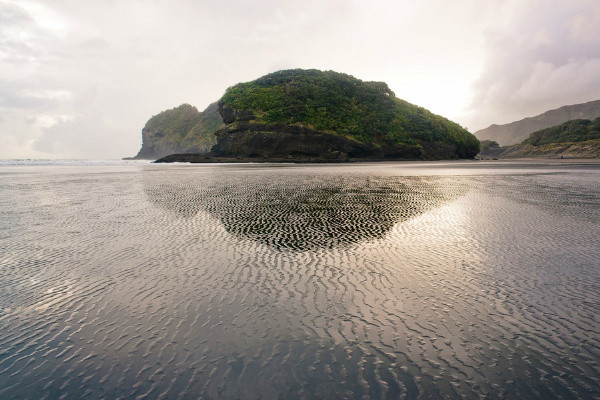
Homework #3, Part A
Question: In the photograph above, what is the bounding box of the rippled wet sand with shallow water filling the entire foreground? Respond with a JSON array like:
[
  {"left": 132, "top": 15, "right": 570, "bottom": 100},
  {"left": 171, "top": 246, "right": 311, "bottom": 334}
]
[{"left": 0, "top": 162, "right": 600, "bottom": 399}]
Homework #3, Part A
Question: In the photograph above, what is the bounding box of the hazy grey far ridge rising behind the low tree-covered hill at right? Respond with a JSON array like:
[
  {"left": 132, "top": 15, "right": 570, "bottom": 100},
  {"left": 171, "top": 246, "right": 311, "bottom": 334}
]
[{"left": 475, "top": 100, "right": 600, "bottom": 146}]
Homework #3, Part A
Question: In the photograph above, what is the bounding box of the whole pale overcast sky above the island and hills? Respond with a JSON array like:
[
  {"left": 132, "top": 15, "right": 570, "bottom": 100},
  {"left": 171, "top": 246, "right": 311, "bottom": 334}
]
[{"left": 0, "top": 0, "right": 600, "bottom": 158}]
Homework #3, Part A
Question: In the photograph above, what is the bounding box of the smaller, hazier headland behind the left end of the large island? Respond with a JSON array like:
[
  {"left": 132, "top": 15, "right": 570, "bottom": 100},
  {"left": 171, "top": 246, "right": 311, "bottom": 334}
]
[{"left": 134, "top": 103, "right": 223, "bottom": 159}]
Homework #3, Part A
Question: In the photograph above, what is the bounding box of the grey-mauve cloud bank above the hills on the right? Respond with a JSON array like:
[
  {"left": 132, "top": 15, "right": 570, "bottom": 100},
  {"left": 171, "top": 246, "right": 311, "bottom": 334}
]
[{"left": 466, "top": 0, "right": 600, "bottom": 129}]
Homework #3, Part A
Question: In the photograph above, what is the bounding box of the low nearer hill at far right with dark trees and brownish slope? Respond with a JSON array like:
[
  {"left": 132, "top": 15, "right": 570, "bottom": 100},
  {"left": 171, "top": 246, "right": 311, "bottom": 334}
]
[{"left": 478, "top": 118, "right": 600, "bottom": 159}]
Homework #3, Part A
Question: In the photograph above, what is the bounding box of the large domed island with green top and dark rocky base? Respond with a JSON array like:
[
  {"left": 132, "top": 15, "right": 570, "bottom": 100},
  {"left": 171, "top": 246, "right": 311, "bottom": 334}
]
[{"left": 130, "top": 69, "right": 480, "bottom": 162}]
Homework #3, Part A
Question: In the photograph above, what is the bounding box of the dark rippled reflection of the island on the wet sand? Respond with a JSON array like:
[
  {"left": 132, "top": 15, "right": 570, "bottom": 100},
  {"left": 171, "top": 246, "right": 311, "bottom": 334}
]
[{"left": 145, "top": 171, "right": 467, "bottom": 250}]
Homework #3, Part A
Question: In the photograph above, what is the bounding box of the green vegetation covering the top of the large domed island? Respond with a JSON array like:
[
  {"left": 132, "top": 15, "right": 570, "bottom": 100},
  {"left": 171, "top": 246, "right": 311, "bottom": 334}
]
[{"left": 217, "top": 69, "right": 479, "bottom": 159}]
